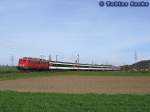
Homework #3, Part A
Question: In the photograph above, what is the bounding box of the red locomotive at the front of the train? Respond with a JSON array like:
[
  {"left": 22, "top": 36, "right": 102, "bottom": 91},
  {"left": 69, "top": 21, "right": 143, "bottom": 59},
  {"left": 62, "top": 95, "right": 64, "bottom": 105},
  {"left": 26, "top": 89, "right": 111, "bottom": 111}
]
[{"left": 18, "top": 57, "right": 49, "bottom": 70}]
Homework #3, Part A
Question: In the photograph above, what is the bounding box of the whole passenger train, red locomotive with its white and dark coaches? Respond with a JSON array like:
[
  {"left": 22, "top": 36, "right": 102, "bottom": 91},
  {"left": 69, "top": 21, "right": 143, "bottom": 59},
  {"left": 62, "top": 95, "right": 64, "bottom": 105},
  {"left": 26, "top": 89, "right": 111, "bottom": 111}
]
[{"left": 18, "top": 57, "right": 120, "bottom": 71}]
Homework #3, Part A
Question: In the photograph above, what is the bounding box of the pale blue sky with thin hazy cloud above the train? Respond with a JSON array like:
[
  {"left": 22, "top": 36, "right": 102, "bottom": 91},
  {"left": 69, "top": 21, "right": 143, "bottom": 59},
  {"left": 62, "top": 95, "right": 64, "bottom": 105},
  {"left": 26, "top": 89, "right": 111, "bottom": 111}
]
[{"left": 0, "top": 0, "right": 150, "bottom": 65}]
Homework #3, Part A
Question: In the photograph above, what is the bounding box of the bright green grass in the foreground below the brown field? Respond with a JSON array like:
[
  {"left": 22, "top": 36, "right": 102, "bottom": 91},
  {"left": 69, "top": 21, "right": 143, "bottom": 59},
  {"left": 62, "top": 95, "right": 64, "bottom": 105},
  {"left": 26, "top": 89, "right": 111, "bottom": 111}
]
[{"left": 0, "top": 91, "right": 150, "bottom": 112}]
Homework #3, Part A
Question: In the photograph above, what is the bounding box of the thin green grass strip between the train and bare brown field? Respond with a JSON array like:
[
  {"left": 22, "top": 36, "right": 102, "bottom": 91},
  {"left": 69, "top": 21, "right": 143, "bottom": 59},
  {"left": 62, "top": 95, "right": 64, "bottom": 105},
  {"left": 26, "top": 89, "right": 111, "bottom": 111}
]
[{"left": 0, "top": 71, "right": 150, "bottom": 80}]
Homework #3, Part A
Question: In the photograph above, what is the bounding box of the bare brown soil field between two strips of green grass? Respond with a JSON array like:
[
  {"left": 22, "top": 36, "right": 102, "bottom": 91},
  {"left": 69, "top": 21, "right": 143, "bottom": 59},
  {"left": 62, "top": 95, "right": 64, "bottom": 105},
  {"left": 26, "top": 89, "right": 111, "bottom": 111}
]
[{"left": 0, "top": 76, "right": 150, "bottom": 94}]
